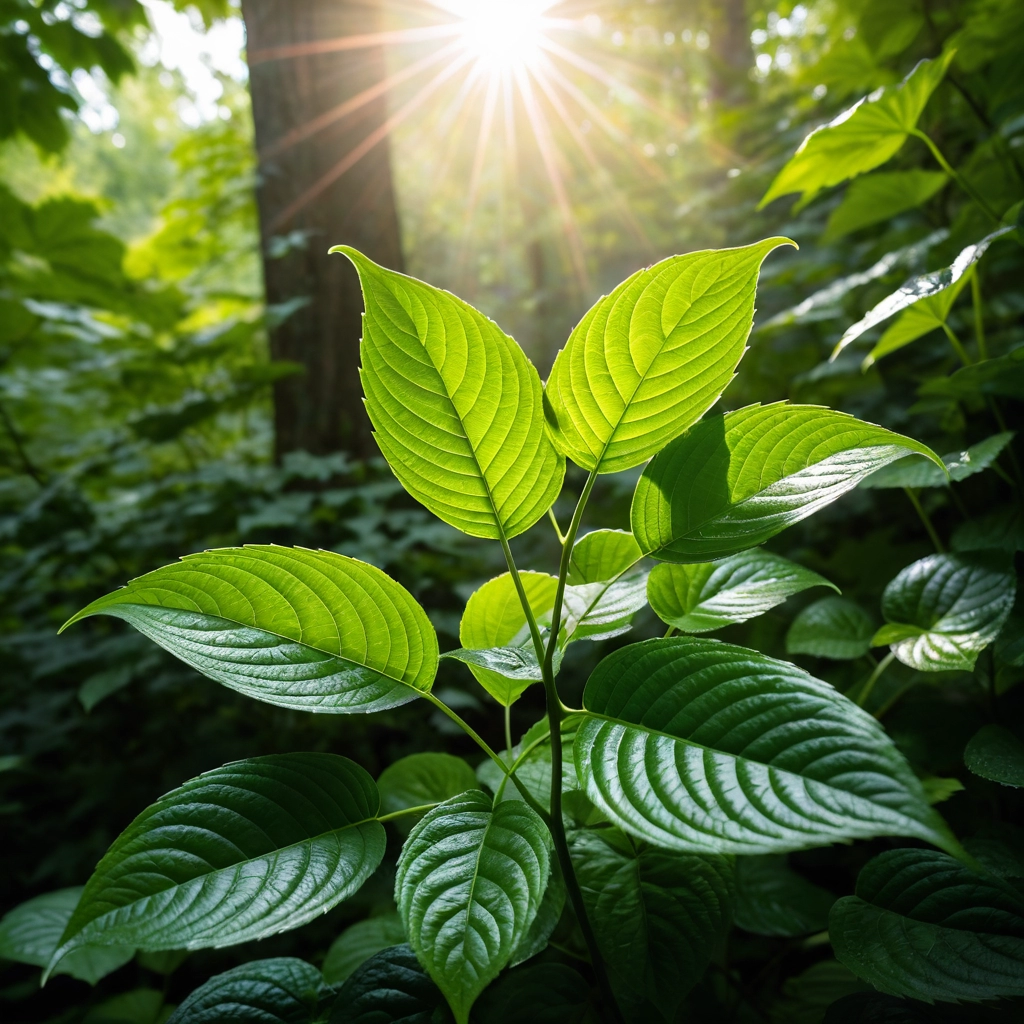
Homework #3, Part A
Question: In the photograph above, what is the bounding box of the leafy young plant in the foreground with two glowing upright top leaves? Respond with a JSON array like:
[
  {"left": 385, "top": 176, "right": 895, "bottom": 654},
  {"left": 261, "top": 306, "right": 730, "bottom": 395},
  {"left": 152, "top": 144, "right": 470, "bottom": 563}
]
[{"left": 48, "top": 239, "right": 974, "bottom": 1024}]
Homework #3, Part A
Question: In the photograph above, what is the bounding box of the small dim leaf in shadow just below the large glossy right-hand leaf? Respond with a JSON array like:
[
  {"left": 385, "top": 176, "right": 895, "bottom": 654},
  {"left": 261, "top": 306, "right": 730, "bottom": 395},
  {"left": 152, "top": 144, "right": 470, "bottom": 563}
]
[{"left": 733, "top": 856, "right": 836, "bottom": 938}]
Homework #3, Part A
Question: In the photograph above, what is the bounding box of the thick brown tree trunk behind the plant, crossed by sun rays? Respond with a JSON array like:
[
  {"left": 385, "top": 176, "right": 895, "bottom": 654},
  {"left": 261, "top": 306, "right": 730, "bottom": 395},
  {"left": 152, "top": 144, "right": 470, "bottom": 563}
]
[{"left": 242, "top": 0, "right": 402, "bottom": 458}]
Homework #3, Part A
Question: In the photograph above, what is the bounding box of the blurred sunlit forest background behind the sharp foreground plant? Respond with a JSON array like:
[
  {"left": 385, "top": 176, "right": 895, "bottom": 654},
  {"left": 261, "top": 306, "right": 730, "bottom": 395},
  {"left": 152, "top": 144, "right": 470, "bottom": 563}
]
[{"left": 0, "top": 0, "right": 1024, "bottom": 1022}]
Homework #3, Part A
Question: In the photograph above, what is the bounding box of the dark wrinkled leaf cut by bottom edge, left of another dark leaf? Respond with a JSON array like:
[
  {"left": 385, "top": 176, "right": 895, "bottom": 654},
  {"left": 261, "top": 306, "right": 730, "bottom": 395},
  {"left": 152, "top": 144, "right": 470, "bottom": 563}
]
[{"left": 167, "top": 956, "right": 334, "bottom": 1024}]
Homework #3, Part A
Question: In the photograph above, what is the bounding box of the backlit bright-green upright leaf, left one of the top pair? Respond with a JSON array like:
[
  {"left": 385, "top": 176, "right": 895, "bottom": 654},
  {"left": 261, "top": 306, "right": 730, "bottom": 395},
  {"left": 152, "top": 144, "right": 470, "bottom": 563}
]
[{"left": 331, "top": 246, "right": 565, "bottom": 540}]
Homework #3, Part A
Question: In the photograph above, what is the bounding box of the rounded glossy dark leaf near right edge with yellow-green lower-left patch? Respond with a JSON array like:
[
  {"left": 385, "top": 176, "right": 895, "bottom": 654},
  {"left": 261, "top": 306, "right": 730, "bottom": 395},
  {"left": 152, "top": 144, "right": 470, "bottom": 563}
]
[{"left": 872, "top": 552, "right": 1017, "bottom": 672}]
